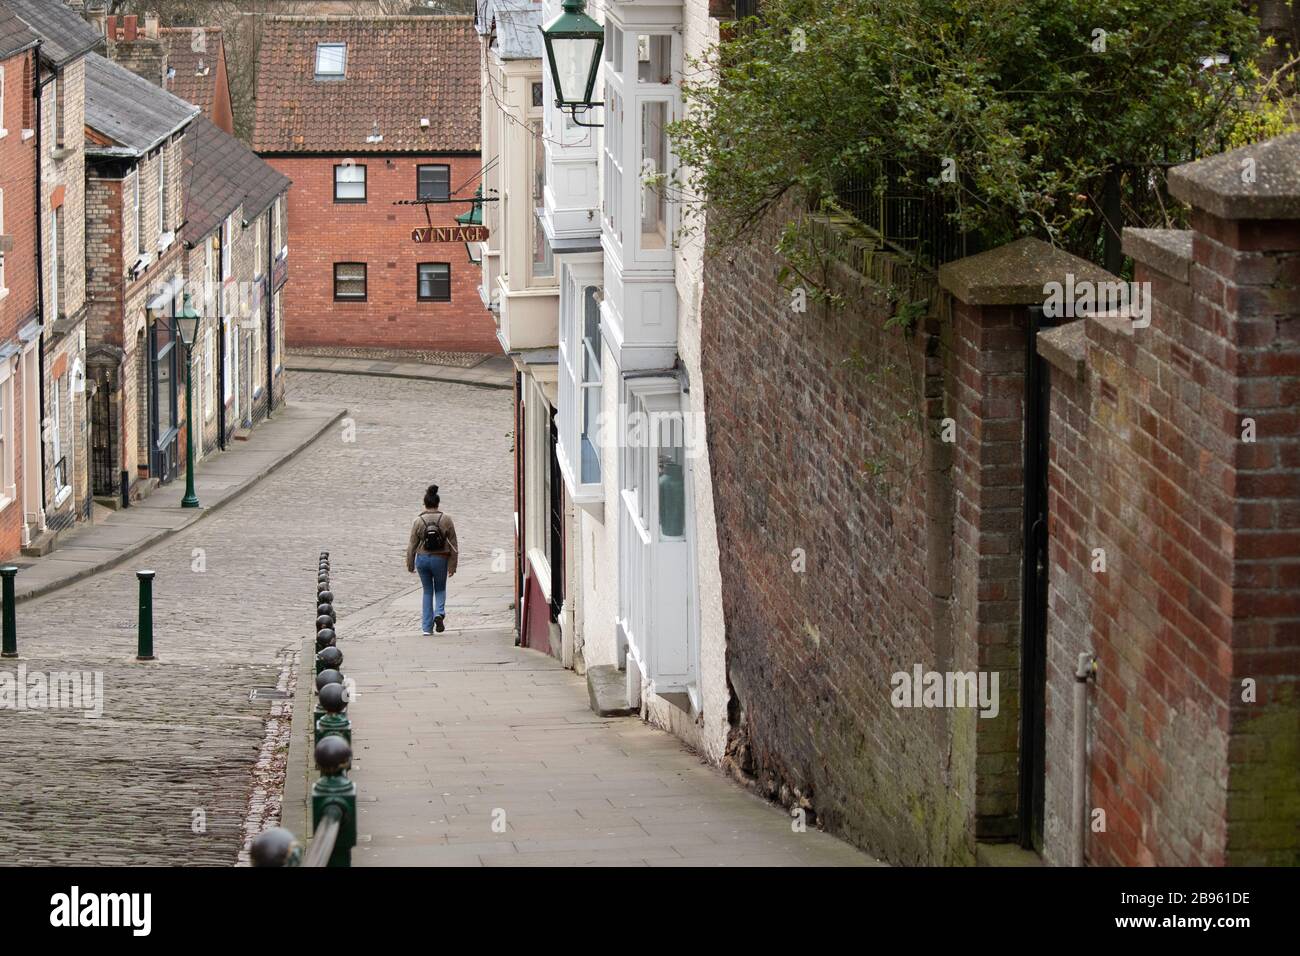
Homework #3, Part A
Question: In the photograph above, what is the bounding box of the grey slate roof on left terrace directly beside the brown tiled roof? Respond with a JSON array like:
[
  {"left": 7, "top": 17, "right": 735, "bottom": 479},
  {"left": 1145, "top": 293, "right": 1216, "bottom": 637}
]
[{"left": 86, "top": 53, "right": 199, "bottom": 156}]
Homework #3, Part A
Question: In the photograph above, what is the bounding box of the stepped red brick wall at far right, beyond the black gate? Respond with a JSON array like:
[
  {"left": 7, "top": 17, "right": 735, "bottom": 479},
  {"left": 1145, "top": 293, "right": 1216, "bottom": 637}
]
[{"left": 1045, "top": 213, "right": 1300, "bottom": 866}]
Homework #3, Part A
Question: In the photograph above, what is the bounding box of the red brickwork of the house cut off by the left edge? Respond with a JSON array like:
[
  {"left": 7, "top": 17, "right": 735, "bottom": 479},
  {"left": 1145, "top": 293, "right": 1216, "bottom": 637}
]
[{"left": 0, "top": 52, "right": 40, "bottom": 559}]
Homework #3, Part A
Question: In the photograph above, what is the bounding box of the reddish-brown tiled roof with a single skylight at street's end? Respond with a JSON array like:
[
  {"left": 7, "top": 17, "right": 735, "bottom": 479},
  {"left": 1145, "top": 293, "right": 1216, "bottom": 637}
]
[{"left": 254, "top": 17, "right": 480, "bottom": 152}]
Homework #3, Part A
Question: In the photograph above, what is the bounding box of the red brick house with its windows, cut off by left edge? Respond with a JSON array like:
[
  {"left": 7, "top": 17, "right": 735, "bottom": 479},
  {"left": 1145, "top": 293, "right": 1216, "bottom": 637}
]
[{"left": 0, "top": 5, "right": 40, "bottom": 559}]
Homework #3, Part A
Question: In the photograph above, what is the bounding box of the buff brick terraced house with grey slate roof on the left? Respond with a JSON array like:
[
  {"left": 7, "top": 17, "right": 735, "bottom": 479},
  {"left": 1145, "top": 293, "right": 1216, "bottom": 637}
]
[{"left": 86, "top": 53, "right": 199, "bottom": 501}]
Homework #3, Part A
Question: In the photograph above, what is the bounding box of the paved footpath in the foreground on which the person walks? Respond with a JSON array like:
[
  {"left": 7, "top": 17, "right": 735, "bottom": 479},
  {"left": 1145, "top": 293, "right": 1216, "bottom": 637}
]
[{"left": 340, "top": 562, "right": 875, "bottom": 866}]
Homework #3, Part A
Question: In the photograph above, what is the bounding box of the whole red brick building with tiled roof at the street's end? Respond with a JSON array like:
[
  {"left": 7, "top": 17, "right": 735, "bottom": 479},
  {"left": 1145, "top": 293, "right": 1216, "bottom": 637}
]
[{"left": 254, "top": 17, "right": 499, "bottom": 352}]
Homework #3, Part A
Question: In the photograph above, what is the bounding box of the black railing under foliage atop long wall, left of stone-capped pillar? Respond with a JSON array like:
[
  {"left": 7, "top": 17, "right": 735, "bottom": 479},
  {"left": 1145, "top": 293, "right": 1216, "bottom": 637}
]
[{"left": 833, "top": 160, "right": 976, "bottom": 269}]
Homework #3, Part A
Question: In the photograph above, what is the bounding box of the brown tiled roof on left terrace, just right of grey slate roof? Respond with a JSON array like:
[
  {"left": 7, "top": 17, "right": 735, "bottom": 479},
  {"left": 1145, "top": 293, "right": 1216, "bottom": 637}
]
[{"left": 181, "top": 116, "right": 290, "bottom": 245}]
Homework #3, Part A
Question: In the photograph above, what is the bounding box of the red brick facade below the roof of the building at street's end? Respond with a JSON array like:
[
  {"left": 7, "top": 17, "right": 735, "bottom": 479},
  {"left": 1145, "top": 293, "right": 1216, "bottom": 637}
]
[{"left": 268, "top": 156, "right": 501, "bottom": 352}]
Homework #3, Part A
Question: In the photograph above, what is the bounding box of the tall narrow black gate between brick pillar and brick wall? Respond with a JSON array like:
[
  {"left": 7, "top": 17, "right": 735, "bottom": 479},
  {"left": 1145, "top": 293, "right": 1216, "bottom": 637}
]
[{"left": 1019, "top": 306, "right": 1061, "bottom": 852}]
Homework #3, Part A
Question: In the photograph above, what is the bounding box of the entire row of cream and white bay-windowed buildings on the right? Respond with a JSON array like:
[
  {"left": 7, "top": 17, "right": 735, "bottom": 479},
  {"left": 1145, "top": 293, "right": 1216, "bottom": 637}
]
[{"left": 478, "top": 0, "right": 731, "bottom": 762}]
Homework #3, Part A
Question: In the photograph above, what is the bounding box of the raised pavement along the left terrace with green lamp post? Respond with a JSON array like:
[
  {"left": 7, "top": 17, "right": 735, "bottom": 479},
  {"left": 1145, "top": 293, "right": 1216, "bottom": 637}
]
[{"left": 3, "top": 402, "right": 347, "bottom": 602}]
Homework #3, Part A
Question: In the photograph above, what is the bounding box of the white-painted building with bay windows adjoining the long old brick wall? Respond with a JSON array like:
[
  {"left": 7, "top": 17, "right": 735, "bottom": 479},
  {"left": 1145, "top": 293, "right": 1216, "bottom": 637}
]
[{"left": 538, "top": 0, "right": 729, "bottom": 762}]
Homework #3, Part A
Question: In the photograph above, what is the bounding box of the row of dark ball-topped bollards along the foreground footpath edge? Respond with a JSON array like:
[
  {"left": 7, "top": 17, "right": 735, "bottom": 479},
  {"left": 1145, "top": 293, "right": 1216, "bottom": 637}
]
[{"left": 251, "top": 551, "right": 356, "bottom": 866}]
